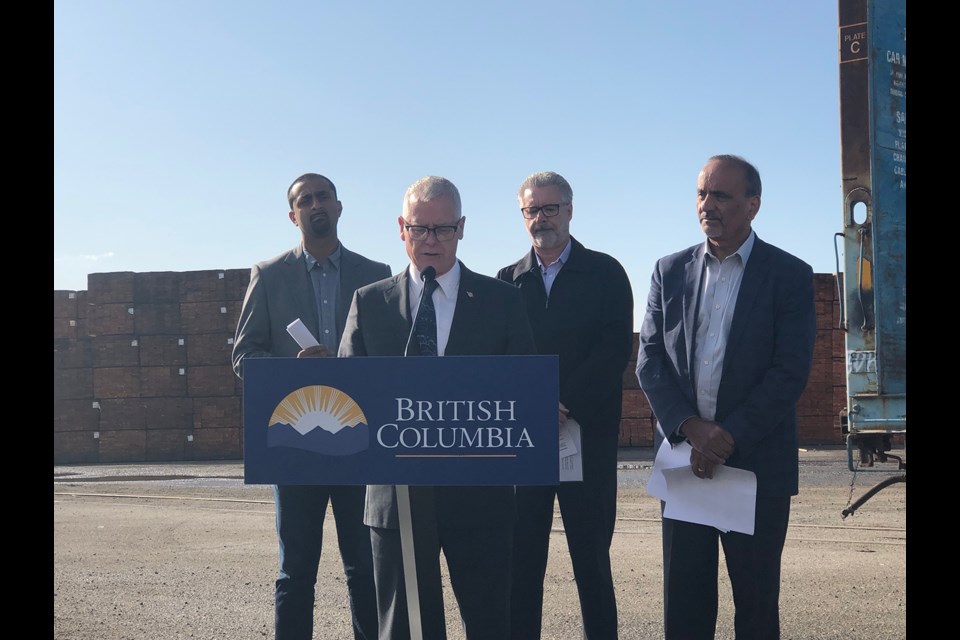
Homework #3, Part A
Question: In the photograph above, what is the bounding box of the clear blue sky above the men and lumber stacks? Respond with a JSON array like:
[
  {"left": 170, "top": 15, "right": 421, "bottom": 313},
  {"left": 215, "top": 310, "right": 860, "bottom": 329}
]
[{"left": 53, "top": 0, "right": 842, "bottom": 317}]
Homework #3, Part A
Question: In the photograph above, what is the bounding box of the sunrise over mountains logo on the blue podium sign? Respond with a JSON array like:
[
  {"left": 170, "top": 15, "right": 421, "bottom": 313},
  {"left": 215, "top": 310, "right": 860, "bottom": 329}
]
[{"left": 267, "top": 385, "right": 370, "bottom": 456}]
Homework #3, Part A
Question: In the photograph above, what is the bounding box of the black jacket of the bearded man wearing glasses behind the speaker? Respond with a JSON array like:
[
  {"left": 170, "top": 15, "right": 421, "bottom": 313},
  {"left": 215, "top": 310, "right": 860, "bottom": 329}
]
[{"left": 497, "top": 238, "right": 633, "bottom": 438}]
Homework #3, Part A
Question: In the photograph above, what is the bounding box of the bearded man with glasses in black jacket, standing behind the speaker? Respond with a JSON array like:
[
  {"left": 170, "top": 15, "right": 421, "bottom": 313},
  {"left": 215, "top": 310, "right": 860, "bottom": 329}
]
[{"left": 497, "top": 171, "right": 633, "bottom": 640}]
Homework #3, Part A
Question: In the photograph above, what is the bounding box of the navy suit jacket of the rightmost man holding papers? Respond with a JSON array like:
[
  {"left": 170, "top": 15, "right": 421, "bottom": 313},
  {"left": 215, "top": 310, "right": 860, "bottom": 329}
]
[{"left": 637, "top": 237, "right": 816, "bottom": 497}]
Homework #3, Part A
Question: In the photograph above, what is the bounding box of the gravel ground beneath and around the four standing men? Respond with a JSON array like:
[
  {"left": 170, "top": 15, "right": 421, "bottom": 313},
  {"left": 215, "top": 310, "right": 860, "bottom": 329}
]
[{"left": 53, "top": 449, "right": 907, "bottom": 640}]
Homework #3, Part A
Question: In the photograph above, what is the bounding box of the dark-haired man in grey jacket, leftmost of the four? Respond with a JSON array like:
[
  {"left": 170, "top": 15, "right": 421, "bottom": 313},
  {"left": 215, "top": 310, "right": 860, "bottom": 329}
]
[{"left": 233, "top": 173, "right": 390, "bottom": 640}]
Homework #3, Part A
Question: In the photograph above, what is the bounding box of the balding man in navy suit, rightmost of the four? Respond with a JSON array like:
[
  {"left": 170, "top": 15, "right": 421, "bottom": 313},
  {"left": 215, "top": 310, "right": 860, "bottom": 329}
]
[{"left": 637, "top": 155, "right": 816, "bottom": 640}]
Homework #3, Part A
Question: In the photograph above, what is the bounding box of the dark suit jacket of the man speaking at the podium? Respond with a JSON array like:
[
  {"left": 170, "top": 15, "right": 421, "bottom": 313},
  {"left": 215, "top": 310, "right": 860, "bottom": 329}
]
[{"left": 340, "top": 263, "right": 535, "bottom": 529}]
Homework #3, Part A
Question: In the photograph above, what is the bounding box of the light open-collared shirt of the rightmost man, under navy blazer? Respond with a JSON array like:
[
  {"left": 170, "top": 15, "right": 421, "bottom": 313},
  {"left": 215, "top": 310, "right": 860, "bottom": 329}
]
[{"left": 693, "top": 231, "right": 756, "bottom": 420}]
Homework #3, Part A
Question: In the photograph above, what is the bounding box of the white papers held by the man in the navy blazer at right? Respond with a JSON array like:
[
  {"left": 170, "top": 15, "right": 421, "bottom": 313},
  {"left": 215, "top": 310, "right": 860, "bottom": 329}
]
[{"left": 647, "top": 430, "right": 757, "bottom": 535}]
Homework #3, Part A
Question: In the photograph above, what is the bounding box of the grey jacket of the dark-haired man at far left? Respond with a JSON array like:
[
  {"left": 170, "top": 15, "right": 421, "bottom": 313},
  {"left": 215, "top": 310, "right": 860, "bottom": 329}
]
[{"left": 233, "top": 244, "right": 390, "bottom": 378}]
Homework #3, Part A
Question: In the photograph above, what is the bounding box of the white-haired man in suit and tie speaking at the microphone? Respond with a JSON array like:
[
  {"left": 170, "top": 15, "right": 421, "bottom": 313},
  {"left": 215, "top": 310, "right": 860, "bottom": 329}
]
[{"left": 340, "top": 176, "right": 535, "bottom": 640}]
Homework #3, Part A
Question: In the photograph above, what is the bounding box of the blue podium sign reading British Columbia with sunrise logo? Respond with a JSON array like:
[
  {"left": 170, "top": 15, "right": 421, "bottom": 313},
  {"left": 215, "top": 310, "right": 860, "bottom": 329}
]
[{"left": 243, "top": 356, "right": 560, "bottom": 485}]
